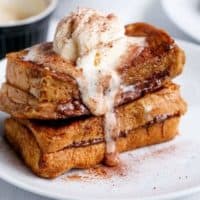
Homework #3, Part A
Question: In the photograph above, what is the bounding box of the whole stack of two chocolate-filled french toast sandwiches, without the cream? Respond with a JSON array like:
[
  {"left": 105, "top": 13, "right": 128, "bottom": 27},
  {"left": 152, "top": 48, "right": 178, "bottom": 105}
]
[{"left": 0, "top": 23, "right": 186, "bottom": 178}]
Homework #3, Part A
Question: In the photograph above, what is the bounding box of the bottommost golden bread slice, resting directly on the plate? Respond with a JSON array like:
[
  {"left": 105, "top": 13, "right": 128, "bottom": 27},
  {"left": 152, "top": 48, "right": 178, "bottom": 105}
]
[{"left": 5, "top": 117, "right": 179, "bottom": 178}]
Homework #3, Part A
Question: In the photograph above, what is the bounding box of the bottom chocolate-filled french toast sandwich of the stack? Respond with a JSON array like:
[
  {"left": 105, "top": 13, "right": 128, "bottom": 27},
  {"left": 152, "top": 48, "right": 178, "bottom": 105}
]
[{"left": 5, "top": 84, "right": 186, "bottom": 178}]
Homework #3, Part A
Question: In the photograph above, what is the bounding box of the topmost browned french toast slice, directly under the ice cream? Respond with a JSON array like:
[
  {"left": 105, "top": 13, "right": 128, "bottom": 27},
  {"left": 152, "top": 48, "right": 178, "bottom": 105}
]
[{"left": 2, "top": 23, "right": 185, "bottom": 119}]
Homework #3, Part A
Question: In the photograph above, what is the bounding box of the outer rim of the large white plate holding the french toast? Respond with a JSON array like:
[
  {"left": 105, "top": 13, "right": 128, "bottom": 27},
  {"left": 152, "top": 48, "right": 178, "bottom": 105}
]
[{"left": 0, "top": 39, "right": 200, "bottom": 200}]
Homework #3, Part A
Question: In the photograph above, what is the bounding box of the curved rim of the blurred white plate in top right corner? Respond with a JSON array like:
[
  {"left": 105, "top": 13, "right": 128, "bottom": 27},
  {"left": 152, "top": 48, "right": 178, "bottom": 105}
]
[{"left": 161, "top": 0, "right": 200, "bottom": 42}]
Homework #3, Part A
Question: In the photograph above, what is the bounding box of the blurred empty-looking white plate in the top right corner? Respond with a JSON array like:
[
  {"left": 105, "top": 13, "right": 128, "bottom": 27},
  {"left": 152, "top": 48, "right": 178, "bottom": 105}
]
[{"left": 162, "top": 0, "right": 200, "bottom": 42}]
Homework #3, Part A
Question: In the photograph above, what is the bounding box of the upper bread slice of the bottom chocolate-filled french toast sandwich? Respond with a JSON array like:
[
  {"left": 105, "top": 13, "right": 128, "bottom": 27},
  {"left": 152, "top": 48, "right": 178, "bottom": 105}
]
[{"left": 2, "top": 83, "right": 186, "bottom": 153}]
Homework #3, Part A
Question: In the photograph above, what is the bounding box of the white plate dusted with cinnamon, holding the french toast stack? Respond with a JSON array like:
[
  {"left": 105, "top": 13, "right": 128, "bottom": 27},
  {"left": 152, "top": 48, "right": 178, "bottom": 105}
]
[{"left": 0, "top": 39, "right": 200, "bottom": 200}]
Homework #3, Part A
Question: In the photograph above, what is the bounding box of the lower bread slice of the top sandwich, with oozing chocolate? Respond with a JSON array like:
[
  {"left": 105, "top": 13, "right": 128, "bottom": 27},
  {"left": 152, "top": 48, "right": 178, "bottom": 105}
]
[{"left": 0, "top": 77, "right": 168, "bottom": 120}]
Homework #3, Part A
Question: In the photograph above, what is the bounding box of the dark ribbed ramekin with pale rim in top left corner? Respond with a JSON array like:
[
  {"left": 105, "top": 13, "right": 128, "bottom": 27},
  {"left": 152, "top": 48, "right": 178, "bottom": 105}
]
[{"left": 0, "top": 0, "right": 57, "bottom": 59}]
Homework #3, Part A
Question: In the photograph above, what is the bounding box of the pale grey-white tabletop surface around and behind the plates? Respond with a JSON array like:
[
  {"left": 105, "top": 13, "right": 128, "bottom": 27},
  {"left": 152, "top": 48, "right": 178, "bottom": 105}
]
[{"left": 0, "top": 0, "right": 200, "bottom": 200}]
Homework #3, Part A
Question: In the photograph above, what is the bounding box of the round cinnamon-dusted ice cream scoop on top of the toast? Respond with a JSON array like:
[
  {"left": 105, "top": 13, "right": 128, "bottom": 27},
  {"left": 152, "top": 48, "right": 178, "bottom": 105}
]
[{"left": 53, "top": 9, "right": 124, "bottom": 61}]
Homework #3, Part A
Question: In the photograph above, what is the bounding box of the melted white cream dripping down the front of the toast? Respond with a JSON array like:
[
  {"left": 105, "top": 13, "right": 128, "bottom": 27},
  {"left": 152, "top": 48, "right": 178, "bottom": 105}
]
[{"left": 76, "top": 37, "right": 145, "bottom": 166}]
